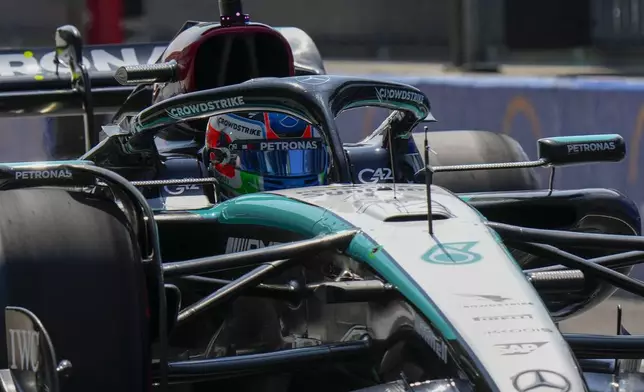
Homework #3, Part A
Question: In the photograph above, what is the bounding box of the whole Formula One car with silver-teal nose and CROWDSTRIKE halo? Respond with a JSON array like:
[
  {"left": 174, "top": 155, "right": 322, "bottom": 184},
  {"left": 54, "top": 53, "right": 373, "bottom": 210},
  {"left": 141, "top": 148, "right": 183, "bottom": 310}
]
[{"left": 0, "top": 1, "right": 644, "bottom": 392}]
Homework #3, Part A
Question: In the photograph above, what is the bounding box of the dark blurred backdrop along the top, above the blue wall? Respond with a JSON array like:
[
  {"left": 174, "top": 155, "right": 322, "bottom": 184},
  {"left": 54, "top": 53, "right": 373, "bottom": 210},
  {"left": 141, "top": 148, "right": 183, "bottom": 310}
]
[{"left": 5, "top": 0, "right": 644, "bottom": 68}]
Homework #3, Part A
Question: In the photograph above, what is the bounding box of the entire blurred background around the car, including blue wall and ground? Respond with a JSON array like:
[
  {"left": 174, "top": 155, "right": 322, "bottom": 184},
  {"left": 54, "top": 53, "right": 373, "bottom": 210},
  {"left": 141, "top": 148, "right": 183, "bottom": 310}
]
[{"left": 0, "top": 0, "right": 644, "bottom": 333}]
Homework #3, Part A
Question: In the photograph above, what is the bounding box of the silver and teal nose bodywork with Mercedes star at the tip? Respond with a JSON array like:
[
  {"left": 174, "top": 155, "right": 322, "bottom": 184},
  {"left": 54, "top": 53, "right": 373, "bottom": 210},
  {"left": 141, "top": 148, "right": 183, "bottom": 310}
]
[{"left": 177, "top": 184, "right": 584, "bottom": 391}]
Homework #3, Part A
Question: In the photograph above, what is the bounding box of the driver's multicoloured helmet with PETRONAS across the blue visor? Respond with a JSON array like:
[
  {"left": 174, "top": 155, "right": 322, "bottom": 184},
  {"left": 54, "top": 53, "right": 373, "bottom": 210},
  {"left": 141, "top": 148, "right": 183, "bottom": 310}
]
[{"left": 204, "top": 112, "right": 330, "bottom": 197}]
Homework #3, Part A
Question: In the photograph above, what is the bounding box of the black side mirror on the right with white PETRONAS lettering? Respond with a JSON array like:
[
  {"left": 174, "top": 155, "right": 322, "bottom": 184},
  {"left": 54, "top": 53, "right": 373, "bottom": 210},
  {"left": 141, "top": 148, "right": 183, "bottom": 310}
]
[{"left": 537, "top": 134, "right": 626, "bottom": 166}]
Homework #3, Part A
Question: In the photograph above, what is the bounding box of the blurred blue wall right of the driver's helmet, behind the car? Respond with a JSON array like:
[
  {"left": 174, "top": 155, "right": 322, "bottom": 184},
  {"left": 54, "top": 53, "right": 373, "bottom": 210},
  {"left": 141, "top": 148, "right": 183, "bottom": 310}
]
[{"left": 339, "top": 75, "right": 644, "bottom": 214}]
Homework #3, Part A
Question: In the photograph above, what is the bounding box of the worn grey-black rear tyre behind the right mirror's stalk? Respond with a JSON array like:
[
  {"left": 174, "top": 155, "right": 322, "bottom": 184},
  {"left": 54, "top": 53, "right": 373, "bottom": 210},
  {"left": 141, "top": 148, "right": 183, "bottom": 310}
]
[{"left": 413, "top": 131, "right": 539, "bottom": 193}]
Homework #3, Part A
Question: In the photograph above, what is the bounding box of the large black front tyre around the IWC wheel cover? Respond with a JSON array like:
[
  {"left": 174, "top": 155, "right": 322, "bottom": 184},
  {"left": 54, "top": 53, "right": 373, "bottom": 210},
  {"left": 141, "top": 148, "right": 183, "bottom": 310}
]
[{"left": 0, "top": 188, "right": 150, "bottom": 392}]
